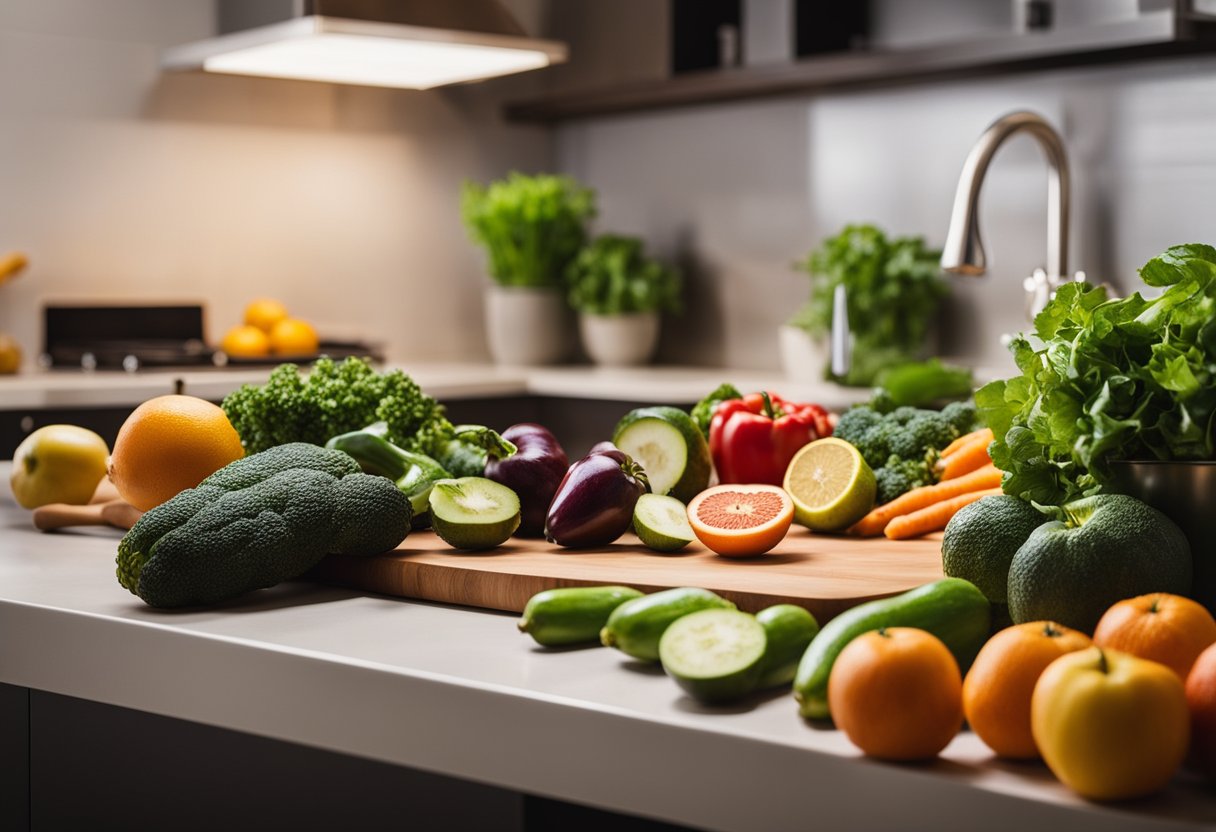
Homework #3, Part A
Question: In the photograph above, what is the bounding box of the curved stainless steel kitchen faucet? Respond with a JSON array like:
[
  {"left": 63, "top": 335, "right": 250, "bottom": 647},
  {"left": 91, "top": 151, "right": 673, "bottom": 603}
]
[{"left": 941, "top": 111, "right": 1085, "bottom": 319}]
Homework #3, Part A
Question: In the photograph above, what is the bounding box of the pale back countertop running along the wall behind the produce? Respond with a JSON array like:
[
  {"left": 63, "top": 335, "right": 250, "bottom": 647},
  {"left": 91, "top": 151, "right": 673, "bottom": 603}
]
[{"left": 0, "top": 362, "right": 869, "bottom": 410}]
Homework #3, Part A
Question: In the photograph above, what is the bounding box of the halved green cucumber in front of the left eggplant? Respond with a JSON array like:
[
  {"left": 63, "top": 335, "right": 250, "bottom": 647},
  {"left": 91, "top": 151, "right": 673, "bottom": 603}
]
[{"left": 430, "top": 477, "right": 519, "bottom": 550}]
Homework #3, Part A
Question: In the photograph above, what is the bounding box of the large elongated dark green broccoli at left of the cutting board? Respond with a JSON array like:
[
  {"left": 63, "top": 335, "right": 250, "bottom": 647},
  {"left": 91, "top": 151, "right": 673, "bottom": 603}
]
[{"left": 118, "top": 443, "right": 411, "bottom": 607}]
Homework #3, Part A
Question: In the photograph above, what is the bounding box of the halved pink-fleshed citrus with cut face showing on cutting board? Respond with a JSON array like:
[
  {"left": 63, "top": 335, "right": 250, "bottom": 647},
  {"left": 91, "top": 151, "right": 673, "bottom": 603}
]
[{"left": 688, "top": 484, "right": 794, "bottom": 557}]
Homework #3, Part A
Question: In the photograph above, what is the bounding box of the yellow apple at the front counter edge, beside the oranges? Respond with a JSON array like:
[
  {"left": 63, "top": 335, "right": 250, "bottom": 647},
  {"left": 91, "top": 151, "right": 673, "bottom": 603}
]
[{"left": 1030, "top": 647, "right": 1190, "bottom": 800}]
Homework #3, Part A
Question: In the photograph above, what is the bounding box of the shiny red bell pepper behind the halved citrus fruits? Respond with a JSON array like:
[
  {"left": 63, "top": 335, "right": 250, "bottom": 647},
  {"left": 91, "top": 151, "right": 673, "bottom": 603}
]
[{"left": 709, "top": 393, "right": 832, "bottom": 485}]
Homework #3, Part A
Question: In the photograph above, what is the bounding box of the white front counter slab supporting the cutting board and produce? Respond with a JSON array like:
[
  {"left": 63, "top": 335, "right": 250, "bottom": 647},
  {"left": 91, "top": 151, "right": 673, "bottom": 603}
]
[{"left": 0, "top": 466, "right": 1216, "bottom": 832}]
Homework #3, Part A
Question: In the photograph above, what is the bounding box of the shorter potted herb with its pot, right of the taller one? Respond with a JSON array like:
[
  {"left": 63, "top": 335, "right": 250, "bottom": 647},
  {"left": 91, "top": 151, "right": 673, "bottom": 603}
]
[{"left": 567, "top": 234, "right": 681, "bottom": 366}]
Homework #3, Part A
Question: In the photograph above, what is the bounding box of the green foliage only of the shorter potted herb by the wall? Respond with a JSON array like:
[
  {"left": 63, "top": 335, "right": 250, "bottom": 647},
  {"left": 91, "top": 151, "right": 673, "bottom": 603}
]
[{"left": 565, "top": 234, "right": 681, "bottom": 315}]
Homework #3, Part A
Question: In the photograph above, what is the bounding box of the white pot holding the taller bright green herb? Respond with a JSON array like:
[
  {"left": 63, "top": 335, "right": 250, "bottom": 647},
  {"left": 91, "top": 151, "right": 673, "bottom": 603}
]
[{"left": 485, "top": 286, "right": 574, "bottom": 365}]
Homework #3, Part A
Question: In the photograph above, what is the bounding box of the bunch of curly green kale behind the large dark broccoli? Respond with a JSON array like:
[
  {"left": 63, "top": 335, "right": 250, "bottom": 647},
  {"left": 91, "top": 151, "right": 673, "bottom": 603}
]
[{"left": 223, "top": 358, "right": 513, "bottom": 477}]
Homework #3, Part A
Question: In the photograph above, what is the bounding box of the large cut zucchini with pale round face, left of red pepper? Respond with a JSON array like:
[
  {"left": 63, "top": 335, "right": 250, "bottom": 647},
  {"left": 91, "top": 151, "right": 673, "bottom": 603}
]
[{"left": 612, "top": 407, "right": 710, "bottom": 502}]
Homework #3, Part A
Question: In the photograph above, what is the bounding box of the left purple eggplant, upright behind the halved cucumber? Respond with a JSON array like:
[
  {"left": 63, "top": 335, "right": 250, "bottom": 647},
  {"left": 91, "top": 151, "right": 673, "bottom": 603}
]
[{"left": 485, "top": 422, "right": 570, "bottom": 538}]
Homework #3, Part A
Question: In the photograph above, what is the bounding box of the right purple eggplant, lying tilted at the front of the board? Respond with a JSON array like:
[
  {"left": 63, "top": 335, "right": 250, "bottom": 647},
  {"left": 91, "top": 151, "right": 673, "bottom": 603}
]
[{"left": 545, "top": 449, "right": 651, "bottom": 549}]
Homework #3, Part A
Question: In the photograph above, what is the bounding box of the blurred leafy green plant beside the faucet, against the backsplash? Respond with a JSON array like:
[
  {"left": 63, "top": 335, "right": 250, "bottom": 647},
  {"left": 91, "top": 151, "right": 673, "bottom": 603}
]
[{"left": 790, "top": 225, "right": 947, "bottom": 386}]
